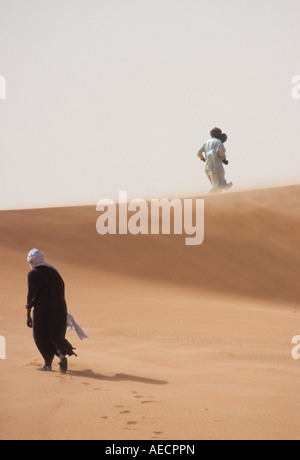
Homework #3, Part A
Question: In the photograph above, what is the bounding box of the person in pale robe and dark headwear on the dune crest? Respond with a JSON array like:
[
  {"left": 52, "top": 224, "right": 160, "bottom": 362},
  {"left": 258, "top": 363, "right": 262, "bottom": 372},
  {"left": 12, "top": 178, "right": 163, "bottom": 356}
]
[{"left": 197, "top": 128, "right": 233, "bottom": 193}]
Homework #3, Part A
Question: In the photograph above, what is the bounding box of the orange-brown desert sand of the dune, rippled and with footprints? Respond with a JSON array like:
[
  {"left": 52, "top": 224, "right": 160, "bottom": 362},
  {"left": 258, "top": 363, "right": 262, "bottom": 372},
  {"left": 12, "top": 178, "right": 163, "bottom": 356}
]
[{"left": 0, "top": 186, "right": 300, "bottom": 440}]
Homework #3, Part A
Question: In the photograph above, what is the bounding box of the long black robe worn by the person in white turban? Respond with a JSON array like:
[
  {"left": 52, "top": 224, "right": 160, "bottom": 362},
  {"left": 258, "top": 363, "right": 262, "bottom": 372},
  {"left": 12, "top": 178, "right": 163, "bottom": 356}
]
[{"left": 26, "top": 265, "right": 75, "bottom": 366}]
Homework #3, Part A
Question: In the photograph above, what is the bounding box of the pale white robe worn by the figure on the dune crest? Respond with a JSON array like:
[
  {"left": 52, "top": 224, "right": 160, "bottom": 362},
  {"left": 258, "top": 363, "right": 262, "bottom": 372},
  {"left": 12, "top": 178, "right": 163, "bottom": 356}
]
[{"left": 198, "top": 138, "right": 227, "bottom": 191}]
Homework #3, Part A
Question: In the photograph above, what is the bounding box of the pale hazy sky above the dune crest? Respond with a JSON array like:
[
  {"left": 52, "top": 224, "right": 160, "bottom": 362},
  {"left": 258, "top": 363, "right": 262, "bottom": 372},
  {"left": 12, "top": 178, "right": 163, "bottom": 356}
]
[{"left": 0, "top": 0, "right": 300, "bottom": 209}]
